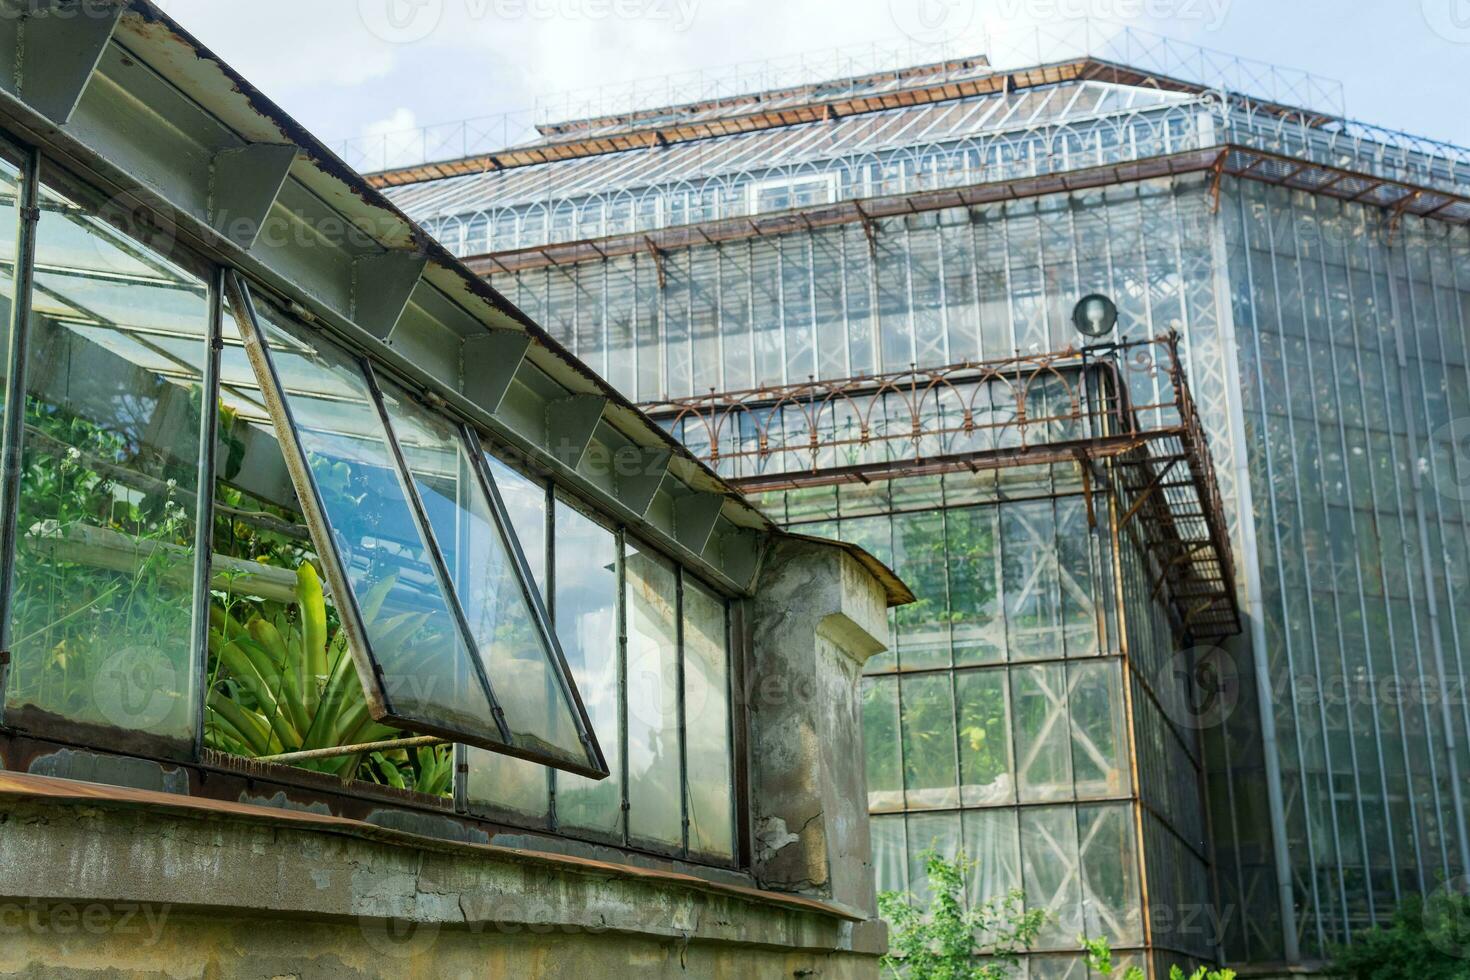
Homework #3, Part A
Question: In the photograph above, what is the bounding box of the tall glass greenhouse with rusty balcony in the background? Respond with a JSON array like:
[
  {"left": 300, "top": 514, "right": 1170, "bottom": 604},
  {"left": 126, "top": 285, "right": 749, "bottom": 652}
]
[{"left": 376, "top": 25, "right": 1470, "bottom": 977}]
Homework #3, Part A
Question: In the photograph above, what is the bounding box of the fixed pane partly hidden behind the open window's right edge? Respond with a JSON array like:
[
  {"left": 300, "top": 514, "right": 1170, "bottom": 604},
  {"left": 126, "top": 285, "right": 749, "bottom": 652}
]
[{"left": 465, "top": 455, "right": 551, "bottom": 820}]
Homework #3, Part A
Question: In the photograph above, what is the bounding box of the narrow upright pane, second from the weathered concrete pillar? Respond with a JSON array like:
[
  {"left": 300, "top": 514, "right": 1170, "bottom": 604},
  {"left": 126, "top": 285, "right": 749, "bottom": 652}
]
[{"left": 625, "top": 542, "right": 684, "bottom": 846}]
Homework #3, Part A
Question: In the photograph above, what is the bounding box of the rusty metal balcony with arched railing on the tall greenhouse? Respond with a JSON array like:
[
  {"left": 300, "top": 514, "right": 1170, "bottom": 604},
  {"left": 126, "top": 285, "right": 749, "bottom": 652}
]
[{"left": 644, "top": 334, "right": 1241, "bottom": 639}]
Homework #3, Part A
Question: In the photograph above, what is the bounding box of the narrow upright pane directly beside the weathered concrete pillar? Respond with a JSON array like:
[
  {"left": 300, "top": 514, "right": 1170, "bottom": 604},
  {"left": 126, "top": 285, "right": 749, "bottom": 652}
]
[{"left": 684, "top": 576, "right": 735, "bottom": 858}]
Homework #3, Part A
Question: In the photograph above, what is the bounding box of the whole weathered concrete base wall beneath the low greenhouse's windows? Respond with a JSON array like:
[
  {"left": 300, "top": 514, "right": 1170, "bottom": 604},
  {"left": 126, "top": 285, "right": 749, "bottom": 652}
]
[{"left": 0, "top": 776, "right": 878, "bottom": 980}]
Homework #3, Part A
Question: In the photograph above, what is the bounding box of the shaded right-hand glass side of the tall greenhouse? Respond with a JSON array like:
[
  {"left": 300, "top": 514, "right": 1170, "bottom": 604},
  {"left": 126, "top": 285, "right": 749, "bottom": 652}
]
[{"left": 1222, "top": 182, "right": 1470, "bottom": 956}]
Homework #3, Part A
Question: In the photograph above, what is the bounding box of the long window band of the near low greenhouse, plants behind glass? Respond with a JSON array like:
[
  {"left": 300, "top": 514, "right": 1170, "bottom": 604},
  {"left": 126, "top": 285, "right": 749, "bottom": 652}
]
[{"left": 0, "top": 139, "right": 738, "bottom": 865}]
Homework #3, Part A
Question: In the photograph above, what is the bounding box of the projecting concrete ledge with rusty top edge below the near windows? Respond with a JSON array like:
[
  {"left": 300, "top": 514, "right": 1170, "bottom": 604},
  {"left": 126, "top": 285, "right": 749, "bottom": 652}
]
[{"left": 0, "top": 773, "right": 878, "bottom": 976}]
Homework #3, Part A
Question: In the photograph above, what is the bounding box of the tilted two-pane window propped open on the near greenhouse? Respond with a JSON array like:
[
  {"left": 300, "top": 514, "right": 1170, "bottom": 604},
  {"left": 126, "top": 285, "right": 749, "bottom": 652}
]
[{"left": 223, "top": 271, "right": 607, "bottom": 779}]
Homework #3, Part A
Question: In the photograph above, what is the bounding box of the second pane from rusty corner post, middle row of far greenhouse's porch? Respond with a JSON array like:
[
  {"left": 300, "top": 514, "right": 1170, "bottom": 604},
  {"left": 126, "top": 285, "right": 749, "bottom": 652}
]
[{"left": 1011, "top": 664, "right": 1073, "bottom": 804}]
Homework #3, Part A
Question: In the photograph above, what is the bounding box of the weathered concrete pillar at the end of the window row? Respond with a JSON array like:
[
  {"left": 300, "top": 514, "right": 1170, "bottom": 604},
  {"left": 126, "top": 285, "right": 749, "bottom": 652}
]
[{"left": 748, "top": 539, "right": 888, "bottom": 945}]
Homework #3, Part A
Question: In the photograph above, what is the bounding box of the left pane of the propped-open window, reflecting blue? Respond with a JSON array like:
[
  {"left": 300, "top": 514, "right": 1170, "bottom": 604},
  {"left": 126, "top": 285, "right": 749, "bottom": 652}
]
[{"left": 259, "top": 306, "right": 501, "bottom": 743}]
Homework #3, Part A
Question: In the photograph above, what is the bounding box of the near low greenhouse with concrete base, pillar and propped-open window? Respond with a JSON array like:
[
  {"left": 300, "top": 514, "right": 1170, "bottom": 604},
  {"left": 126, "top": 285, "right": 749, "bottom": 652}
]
[{"left": 0, "top": 0, "right": 914, "bottom": 979}]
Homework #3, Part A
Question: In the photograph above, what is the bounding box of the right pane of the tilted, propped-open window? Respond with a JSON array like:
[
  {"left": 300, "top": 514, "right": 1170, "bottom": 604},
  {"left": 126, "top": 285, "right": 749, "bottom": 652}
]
[{"left": 381, "top": 383, "right": 595, "bottom": 765}]
